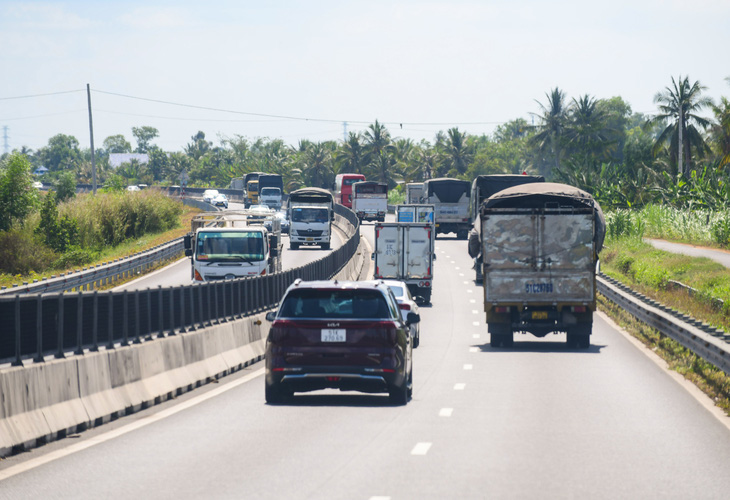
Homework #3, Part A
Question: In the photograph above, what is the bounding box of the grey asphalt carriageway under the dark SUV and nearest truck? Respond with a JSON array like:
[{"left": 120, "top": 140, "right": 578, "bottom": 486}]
[{"left": 0, "top": 221, "right": 730, "bottom": 499}]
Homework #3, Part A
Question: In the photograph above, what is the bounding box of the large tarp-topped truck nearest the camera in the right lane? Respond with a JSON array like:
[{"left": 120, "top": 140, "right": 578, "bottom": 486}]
[{"left": 480, "top": 183, "right": 606, "bottom": 348}]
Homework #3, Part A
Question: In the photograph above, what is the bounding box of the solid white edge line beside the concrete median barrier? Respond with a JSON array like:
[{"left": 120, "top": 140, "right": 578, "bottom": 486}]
[{"left": 0, "top": 368, "right": 266, "bottom": 481}]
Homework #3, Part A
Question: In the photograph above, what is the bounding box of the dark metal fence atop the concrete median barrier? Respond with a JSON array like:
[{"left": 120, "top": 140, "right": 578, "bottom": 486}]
[{"left": 0, "top": 206, "right": 360, "bottom": 365}]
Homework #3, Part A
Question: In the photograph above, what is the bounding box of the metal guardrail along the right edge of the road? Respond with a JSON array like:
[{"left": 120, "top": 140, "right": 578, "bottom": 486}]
[{"left": 597, "top": 274, "right": 730, "bottom": 375}]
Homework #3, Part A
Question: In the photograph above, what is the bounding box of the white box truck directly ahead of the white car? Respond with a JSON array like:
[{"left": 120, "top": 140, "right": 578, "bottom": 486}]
[{"left": 373, "top": 222, "right": 433, "bottom": 303}]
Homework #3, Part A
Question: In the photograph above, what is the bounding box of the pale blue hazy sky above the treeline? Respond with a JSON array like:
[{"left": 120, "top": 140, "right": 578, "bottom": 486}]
[{"left": 0, "top": 0, "right": 730, "bottom": 153}]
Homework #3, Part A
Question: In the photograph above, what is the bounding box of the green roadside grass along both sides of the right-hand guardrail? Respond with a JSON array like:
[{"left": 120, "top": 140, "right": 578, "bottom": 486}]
[{"left": 599, "top": 237, "right": 730, "bottom": 416}]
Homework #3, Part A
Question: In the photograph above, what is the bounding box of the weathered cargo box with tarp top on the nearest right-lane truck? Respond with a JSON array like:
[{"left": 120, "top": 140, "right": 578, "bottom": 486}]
[{"left": 481, "top": 183, "right": 605, "bottom": 304}]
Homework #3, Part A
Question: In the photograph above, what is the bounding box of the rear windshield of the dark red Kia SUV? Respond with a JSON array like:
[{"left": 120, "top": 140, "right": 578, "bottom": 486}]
[{"left": 279, "top": 288, "right": 394, "bottom": 319}]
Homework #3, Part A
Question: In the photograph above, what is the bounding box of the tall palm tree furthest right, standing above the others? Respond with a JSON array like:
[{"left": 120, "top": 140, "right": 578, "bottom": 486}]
[{"left": 647, "top": 75, "right": 712, "bottom": 175}]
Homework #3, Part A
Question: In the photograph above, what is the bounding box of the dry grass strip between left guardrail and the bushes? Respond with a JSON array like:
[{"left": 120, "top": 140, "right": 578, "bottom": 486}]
[{"left": 0, "top": 205, "right": 200, "bottom": 288}]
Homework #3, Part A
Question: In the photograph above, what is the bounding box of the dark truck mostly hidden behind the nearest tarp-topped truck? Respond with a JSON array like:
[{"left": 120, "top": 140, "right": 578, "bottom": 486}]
[{"left": 468, "top": 174, "right": 545, "bottom": 283}]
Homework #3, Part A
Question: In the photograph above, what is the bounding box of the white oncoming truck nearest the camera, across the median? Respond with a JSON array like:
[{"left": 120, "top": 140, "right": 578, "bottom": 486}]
[{"left": 184, "top": 210, "right": 282, "bottom": 281}]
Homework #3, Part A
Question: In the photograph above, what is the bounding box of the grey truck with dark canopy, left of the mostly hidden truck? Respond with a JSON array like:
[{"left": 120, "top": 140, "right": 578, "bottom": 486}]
[{"left": 423, "top": 177, "right": 471, "bottom": 240}]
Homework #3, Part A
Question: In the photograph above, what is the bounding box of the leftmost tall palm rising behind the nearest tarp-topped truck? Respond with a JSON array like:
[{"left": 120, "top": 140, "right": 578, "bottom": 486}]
[{"left": 530, "top": 87, "right": 568, "bottom": 177}]
